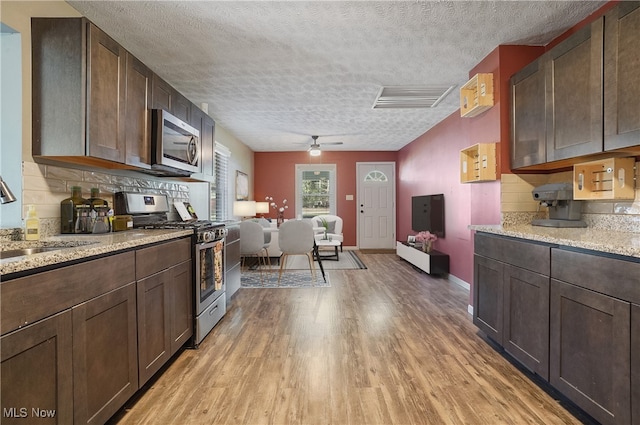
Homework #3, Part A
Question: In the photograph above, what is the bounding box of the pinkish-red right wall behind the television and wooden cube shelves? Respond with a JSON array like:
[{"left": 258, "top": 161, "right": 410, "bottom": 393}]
[{"left": 397, "top": 46, "right": 544, "bottom": 304}]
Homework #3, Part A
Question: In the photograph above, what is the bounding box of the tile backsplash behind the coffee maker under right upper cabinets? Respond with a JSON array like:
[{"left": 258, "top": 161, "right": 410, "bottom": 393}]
[{"left": 500, "top": 162, "right": 640, "bottom": 233}]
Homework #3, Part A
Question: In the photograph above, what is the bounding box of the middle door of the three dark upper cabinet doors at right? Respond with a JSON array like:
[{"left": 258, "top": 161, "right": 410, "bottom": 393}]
[{"left": 545, "top": 17, "right": 604, "bottom": 162}]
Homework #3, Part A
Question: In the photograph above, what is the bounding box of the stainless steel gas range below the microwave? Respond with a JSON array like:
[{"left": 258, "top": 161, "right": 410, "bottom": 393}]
[{"left": 114, "top": 192, "right": 227, "bottom": 348}]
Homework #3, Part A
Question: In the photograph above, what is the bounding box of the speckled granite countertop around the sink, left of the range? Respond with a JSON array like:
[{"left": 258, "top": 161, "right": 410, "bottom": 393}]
[{"left": 0, "top": 229, "right": 193, "bottom": 280}]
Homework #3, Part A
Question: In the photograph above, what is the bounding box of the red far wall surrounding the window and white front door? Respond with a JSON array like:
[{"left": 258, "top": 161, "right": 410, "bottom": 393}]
[{"left": 253, "top": 151, "right": 398, "bottom": 246}]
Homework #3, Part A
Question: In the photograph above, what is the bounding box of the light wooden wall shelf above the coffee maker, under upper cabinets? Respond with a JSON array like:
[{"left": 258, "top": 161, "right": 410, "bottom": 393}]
[{"left": 573, "top": 158, "right": 636, "bottom": 200}]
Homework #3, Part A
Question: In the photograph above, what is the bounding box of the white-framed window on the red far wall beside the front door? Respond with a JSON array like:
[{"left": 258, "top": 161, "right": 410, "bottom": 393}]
[{"left": 296, "top": 164, "right": 336, "bottom": 218}]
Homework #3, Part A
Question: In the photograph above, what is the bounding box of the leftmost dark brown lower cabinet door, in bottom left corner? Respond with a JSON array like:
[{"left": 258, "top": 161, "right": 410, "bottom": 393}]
[{"left": 0, "top": 310, "right": 73, "bottom": 425}]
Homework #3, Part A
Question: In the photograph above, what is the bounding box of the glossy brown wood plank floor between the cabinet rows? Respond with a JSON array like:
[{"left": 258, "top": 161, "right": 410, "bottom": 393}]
[{"left": 112, "top": 253, "right": 596, "bottom": 425}]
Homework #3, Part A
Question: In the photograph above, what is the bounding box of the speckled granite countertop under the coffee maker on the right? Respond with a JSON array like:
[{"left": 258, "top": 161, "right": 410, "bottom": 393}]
[{"left": 469, "top": 224, "right": 640, "bottom": 258}]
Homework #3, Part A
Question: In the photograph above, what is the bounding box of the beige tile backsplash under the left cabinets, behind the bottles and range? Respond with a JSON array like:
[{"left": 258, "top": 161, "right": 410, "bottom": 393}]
[{"left": 22, "top": 162, "right": 189, "bottom": 236}]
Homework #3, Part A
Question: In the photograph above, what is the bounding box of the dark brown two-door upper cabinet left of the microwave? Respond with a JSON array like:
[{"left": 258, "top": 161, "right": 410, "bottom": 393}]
[{"left": 31, "top": 18, "right": 151, "bottom": 168}]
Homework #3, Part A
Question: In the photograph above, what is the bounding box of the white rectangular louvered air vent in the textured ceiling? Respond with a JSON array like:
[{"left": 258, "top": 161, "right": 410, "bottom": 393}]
[{"left": 373, "top": 85, "right": 456, "bottom": 109}]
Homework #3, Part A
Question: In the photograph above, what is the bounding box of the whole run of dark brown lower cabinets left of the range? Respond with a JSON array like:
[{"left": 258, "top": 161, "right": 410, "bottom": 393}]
[{"left": 0, "top": 238, "right": 193, "bottom": 425}]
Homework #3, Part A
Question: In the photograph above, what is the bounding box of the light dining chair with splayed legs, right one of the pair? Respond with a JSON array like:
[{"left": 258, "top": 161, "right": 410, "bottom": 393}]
[{"left": 278, "top": 220, "right": 316, "bottom": 286}]
